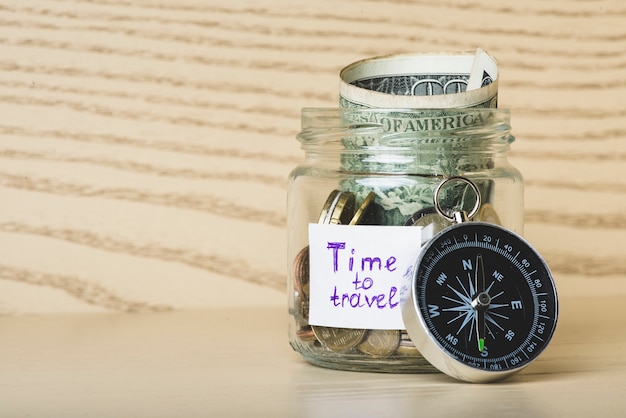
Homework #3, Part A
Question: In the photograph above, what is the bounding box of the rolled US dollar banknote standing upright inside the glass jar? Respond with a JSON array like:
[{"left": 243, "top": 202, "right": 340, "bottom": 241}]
[{"left": 340, "top": 48, "right": 498, "bottom": 225}]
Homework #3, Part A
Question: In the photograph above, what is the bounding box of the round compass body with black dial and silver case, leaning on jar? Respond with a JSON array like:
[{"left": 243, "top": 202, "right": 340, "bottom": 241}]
[{"left": 403, "top": 222, "right": 558, "bottom": 381}]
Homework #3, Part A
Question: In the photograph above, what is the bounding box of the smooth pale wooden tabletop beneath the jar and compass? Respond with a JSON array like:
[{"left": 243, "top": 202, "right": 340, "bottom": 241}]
[{"left": 0, "top": 296, "right": 626, "bottom": 418}]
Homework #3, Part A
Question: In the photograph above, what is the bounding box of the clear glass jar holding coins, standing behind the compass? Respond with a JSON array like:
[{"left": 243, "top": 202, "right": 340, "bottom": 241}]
[{"left": 287, "top": 108, "right": 523, "bottom": 373}]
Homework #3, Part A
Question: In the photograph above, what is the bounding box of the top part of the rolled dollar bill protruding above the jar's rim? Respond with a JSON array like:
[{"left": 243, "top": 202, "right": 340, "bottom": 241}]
[{"left": 340, "top": 48, "right": 498, "bottom": 109}]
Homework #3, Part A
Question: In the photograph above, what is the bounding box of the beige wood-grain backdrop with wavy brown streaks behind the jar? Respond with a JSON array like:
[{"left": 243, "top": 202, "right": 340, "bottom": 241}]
[{"left": 0, "top": 0, "right": 626, "bottom": 315}]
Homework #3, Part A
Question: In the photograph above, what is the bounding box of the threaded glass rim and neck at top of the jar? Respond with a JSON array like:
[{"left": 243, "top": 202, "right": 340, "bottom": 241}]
[{"left": 297, "top": 107, "right": 515, "bottom": 150}]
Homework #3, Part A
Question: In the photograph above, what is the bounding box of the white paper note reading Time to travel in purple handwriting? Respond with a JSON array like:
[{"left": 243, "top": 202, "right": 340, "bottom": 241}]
[{"left": 309, "top": 224, "right": 422, "bottom": 329}]
